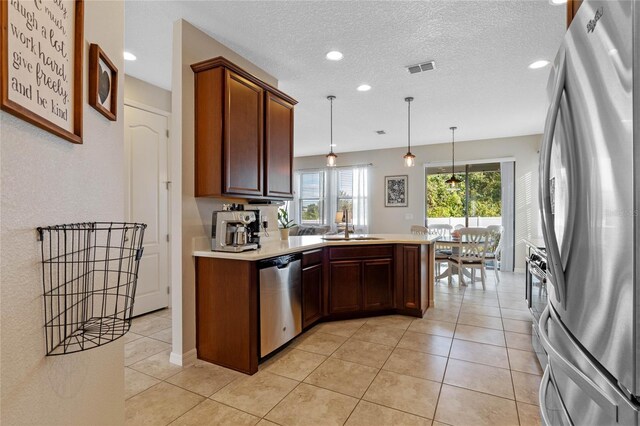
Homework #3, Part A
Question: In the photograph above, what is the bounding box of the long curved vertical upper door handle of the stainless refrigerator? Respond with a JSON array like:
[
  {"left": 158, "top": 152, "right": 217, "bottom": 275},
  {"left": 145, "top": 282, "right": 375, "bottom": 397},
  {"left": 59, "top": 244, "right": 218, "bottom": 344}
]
[{"left": 539, "top": 53, "right": 566, "bottom": 308}]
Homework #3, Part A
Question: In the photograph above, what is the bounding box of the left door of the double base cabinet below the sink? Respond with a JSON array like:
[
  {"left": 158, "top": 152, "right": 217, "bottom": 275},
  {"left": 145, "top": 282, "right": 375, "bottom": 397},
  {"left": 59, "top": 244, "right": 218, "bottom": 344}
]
[{"left": 329, "top": 261, "right": 362, "bottom": 314}]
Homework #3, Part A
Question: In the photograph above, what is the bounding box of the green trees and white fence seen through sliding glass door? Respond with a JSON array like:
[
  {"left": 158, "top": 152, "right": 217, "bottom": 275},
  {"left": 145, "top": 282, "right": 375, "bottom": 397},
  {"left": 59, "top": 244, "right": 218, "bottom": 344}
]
[{"left": 425, "top": 163, "right": 502, "bottom": 227}]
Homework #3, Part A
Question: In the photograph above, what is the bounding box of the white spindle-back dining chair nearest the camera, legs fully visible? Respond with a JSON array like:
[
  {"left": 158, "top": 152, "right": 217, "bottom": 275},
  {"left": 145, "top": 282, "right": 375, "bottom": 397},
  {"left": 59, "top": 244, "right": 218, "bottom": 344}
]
[{"left": 449, "top": 228, "right": 489, "bottom": 290}]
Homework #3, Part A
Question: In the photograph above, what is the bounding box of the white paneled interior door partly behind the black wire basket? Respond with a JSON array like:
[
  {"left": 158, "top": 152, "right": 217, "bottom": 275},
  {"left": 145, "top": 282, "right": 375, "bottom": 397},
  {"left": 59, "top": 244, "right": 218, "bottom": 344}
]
[{"left": 124, "top": 105, "right": 169, "bottom": 315}]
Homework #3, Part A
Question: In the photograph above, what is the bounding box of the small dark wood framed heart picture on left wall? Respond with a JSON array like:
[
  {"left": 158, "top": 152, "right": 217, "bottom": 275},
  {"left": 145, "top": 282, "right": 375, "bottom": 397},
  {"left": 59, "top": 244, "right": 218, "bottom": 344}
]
[{"left": 89, "top": 44, "right": 118, "bottom": 121}]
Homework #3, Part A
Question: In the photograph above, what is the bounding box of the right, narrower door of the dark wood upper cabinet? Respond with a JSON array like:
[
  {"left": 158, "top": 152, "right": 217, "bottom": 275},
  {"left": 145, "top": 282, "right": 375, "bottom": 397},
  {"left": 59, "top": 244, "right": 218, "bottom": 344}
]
[{"left": 264, "top": 92, "right": 293, "bottom": 198}]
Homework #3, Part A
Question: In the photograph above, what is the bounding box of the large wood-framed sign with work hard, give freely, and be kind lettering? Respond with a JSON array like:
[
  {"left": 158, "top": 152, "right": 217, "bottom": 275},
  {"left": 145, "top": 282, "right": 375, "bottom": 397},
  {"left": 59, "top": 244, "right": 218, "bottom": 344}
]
[{"left": 0, "top": 0, "right": 84, "bottom": 143}]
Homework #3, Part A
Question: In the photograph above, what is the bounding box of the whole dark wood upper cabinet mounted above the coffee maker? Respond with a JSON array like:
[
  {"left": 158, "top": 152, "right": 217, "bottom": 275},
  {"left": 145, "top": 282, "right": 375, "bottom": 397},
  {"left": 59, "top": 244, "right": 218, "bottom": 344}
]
[{"left": 191, "top": 57, "right": 297, "bottom": 199}]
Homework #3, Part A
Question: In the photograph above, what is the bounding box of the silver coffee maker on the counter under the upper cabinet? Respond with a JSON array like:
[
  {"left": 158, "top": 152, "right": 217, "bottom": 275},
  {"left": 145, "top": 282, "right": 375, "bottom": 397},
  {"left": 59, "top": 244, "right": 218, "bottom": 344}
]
[{"left": 211, "top": 210, "right": 260, "bottom": 253}]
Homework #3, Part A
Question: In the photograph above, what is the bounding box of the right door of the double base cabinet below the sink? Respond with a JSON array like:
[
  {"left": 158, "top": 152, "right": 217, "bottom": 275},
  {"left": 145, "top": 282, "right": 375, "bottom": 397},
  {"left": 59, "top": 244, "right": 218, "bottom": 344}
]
[{"left": 362, "top": 259, "right": 393, "bottom": 310}]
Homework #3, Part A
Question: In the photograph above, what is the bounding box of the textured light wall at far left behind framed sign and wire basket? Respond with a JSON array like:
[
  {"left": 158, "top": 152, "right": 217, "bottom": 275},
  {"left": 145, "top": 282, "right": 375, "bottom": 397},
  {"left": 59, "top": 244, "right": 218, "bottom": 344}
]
[{"left": 0, "top": 1, "right": 124, "bottom": 425}]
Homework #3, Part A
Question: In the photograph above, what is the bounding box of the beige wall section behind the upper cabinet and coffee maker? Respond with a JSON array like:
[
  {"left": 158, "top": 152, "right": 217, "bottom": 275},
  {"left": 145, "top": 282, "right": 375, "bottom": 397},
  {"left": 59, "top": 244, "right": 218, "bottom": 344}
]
[{"left": 171, "top": 20, "right": 278, "bottom": 364}]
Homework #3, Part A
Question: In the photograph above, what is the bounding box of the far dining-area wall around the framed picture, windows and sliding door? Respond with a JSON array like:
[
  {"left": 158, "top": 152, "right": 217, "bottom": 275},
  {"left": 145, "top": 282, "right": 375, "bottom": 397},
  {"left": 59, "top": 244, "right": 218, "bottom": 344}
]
[{"left": 294, "top": 135, "right": 542, "bottom": 270}]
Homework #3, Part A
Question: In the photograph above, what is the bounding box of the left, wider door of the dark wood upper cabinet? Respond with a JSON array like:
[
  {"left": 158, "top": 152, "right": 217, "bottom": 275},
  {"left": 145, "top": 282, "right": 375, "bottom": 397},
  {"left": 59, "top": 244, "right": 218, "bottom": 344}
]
[{"left": 223, "top": 70, "right": 264, "bottom": 195}]
